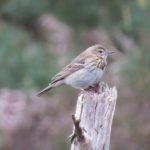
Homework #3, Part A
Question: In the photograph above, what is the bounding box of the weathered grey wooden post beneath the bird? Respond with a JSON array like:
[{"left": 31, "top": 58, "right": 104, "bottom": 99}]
[{"left": 71, "top": 83, "right": 117, "bottom": 150}]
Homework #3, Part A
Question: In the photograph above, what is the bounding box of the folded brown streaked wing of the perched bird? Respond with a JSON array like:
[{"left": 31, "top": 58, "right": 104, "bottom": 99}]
[{"left": 51, "top": 53, "right": 87, "bottom": 84}]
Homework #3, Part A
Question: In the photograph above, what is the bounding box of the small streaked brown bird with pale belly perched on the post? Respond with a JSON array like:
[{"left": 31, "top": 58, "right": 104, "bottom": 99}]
[{"left": 37, "top": 44, "right": 115, "bottom": 96}]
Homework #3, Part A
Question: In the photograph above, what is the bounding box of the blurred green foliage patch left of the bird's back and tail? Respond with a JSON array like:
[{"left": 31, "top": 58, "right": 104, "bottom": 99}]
[{"left": 0, "top": 22, "right": 56, "bottom": 88}]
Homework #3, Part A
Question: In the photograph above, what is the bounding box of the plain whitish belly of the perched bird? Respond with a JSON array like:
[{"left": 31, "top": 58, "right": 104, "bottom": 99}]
[{"left": 65, "top": 69, "right": 104, "bottom": 89}]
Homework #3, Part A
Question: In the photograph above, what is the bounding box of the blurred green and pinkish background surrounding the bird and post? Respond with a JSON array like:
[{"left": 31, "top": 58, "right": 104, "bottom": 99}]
[{"left": 0, "top": 0, "right": 150, "bottom": 150}]
